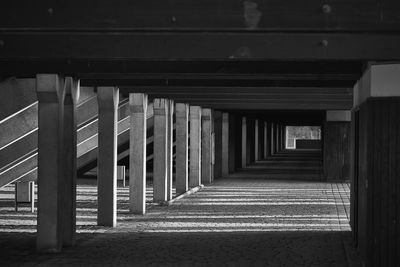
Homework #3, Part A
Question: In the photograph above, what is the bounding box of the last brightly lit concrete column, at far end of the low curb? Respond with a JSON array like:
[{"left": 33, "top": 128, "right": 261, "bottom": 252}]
[{"left": 201, "top": 108, "right": 212, "bottom": 184}]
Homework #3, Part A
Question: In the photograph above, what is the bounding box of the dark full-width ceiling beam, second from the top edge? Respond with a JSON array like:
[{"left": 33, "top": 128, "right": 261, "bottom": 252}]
[{"left": 0, "top": 31, "right": 400, "bottom": 62}]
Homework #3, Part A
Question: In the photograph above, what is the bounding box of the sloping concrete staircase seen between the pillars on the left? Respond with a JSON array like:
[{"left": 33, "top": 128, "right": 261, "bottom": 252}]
[{"left": 0, "top": 79, "right": 153, "bottom": 187}]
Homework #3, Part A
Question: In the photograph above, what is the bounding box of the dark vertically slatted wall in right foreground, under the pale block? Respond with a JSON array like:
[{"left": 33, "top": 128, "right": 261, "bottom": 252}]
[{"left": 353, "top": 98, "right": 400, "bottom": 266}]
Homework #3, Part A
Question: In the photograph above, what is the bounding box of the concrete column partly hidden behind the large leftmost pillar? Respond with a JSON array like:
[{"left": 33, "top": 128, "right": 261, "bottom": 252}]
[{"left": 60, "top": 77, "right": 80, "bottom": 246}]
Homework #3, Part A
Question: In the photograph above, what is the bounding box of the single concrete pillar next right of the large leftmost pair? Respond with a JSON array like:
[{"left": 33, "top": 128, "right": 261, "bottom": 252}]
[{"left": 97, "top": 87, "right": 119, "bottom": 227}]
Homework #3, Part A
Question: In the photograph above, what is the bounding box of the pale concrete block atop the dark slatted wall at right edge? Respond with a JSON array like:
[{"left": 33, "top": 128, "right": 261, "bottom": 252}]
[{"left": 353, "top": 63, "right": 400, "bottom": 107}]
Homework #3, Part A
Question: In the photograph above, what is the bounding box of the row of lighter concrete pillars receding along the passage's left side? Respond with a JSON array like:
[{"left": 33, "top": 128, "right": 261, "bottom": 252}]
[{"left": 37, "top": 74, "right": 234, "bottom": 252}]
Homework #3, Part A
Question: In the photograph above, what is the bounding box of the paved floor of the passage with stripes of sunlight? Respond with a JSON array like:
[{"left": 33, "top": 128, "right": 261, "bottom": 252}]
[{"left": 0, "top": 171, "right": 358, "bottom": 266}]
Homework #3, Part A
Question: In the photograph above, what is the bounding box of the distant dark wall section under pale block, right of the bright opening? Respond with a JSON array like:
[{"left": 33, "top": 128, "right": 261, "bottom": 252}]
[{"left": 319, "top": 122, "right": 351, "bottom": 181}]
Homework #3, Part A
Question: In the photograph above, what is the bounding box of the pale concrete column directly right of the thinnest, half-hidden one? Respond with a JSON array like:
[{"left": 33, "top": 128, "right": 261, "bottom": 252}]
[{"left": 175, "top": 103, "right": 189, "bottom": 195}]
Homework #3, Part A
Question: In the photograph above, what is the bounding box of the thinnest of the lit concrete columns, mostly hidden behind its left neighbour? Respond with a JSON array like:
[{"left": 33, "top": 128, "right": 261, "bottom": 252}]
[{"left": 167, "top": 100, "right": 174, "bottom": 200}]
